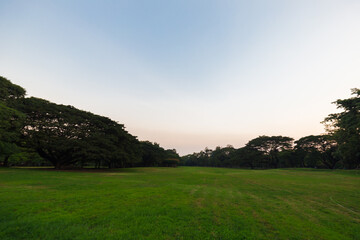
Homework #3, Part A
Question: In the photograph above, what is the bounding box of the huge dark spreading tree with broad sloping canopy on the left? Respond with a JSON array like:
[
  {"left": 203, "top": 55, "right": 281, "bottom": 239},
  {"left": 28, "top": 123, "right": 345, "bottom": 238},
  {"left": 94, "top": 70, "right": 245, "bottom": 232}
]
[{"left": 19, "top": 98, "right": 140, "bottom": 168}]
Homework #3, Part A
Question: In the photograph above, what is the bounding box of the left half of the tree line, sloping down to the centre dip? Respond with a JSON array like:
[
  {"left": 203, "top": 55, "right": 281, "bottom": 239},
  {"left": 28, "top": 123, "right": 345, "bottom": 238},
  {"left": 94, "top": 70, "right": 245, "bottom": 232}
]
[{"left": 0, "top": 76, "right": 180, "bottom": 169}]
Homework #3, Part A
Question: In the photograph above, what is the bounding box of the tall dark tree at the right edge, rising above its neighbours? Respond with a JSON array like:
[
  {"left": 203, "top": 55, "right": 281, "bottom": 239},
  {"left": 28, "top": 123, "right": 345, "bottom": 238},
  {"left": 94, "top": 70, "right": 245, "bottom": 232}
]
[{"left": 323, "top": 88, "right": 360, "bottom": 168}]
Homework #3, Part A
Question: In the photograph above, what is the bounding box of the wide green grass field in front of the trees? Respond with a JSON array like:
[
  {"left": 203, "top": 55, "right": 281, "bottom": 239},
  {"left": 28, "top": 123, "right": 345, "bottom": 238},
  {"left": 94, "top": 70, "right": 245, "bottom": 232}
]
[{"left": 0, "top": 167, "right": 360, "bottom": 240}]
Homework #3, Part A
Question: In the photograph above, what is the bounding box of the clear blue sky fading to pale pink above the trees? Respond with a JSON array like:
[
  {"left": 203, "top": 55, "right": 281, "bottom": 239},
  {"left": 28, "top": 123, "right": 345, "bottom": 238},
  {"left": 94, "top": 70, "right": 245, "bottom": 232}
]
[{"left": 0, "top": 0, "right": 360, "bottom": 155}]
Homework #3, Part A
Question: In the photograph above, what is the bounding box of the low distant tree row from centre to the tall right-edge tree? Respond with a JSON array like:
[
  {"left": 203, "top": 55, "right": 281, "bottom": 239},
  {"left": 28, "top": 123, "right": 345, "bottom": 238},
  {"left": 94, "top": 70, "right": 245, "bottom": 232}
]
[{"left": 181, "top": 135, "right": 342, "bottom": 169}]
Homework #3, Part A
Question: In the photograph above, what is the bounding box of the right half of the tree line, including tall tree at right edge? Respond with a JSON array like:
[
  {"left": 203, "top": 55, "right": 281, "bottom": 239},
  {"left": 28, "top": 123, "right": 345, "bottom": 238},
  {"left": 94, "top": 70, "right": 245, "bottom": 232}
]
[{"left": 180, "top": 89, "right": 360, "bottom": 169}]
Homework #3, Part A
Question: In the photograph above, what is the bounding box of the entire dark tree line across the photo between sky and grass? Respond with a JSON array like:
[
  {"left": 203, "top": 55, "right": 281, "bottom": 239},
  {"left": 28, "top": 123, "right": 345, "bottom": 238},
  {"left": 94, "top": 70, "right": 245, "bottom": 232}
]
[{"left": 0, "top": 76, "right": 360, "bottom": 169}]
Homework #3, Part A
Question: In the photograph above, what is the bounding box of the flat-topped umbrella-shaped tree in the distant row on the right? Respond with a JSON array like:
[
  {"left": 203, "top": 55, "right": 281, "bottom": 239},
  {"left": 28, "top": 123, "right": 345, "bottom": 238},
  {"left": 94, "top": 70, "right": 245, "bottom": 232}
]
[{"left": 246, "top": 136, "right": 294, "bottom": 168}]
